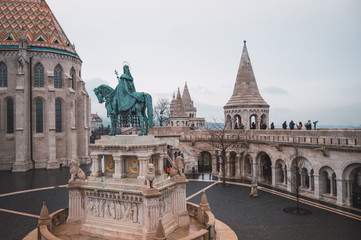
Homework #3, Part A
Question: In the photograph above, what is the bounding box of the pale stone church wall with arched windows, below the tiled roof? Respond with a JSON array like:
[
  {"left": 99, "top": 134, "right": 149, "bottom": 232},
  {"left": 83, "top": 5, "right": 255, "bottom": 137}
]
[{"left": 0, "top": 48, "right": 90, "bottom": 171}]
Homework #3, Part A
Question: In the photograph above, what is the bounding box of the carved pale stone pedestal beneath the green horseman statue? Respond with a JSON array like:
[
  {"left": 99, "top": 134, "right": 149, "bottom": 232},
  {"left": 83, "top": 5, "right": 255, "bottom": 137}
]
[{"left": 68, "top": 136, "right": 189, "bottom": 239}]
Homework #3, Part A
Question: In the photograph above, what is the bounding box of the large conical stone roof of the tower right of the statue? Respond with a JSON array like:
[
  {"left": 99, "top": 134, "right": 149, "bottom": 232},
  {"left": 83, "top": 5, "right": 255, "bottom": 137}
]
[{"left": 225, "top": 41, "right": 269, "bottom": 107}]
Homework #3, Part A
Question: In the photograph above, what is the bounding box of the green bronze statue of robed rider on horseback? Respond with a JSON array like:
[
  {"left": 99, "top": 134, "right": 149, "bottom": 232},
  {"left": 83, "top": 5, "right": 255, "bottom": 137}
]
[{"left": 93, "top": 63, "right": 153, "bottom": 136}]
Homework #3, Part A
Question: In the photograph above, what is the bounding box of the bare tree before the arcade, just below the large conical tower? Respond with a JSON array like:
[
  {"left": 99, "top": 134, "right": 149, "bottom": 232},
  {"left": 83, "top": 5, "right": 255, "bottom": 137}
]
[{"left": 203, "top": 120, "right": 248, "bottom": 186}]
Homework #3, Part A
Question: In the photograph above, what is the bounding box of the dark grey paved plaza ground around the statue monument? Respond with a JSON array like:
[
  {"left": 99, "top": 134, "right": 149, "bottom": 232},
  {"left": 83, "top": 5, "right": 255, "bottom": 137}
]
[{"left": 0, "top": 170, "right": 361, "bottom": 240}]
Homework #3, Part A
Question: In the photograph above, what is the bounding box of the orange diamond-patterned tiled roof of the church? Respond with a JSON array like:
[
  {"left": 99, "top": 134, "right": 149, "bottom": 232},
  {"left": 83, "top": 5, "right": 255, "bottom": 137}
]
[{"left": 0, "top": 0, "right": 78, "bottom": 56}]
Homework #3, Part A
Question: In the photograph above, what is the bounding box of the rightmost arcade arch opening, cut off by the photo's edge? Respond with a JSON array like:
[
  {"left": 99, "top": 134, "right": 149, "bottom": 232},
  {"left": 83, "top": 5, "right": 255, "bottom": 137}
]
[{"left": 342, "top": 163, "right": 361, "bottom": 209}]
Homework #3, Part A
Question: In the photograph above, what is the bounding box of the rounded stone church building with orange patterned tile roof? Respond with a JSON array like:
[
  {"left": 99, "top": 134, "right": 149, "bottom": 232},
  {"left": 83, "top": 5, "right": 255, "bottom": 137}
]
[{"left": 0, "top": 0, "right": 90, "bottom": 171}]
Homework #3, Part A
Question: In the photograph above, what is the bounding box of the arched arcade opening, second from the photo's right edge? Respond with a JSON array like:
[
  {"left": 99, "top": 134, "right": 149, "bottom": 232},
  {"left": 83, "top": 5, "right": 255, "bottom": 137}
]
[{"left": 319, "top": 166, "right": 337, "bottom": 196}]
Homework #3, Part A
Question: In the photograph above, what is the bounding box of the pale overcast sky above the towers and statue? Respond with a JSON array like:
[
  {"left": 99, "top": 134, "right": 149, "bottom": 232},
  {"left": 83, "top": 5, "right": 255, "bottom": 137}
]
[{"left": 47, "top": 0, "right": 361, "bottom": 126}]
